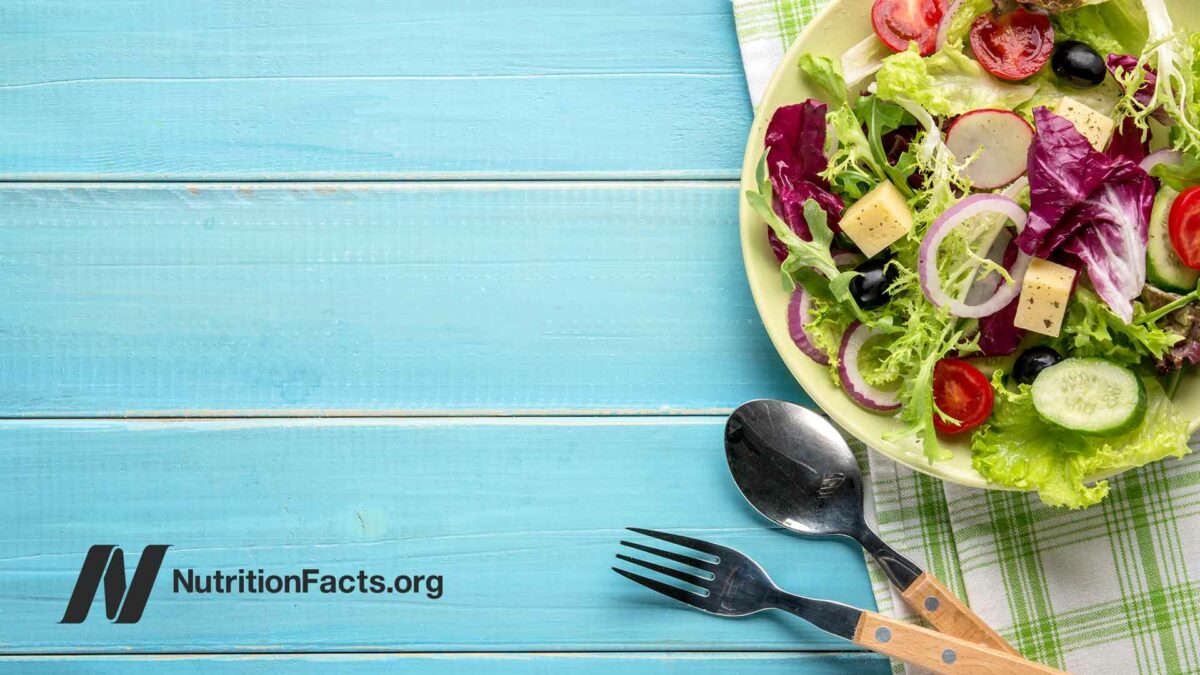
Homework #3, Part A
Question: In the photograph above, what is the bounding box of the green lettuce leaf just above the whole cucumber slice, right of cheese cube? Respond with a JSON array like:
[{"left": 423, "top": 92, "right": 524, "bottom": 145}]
[{"left": 1054, "top": 286, "right": 1183, "bottom": 366}]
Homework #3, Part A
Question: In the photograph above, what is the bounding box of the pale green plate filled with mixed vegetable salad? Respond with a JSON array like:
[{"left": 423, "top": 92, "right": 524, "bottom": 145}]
[{"left": 740, "top": 0, "right": 1200, "bottom": 508}]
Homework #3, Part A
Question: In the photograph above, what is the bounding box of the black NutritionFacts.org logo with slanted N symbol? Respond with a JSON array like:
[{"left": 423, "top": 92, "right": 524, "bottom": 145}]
[{"left": 60, "top": 544, "right": 443, "bottom": 623}]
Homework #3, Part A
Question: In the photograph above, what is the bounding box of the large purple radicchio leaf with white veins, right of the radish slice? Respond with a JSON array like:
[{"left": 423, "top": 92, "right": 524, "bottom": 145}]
[{"left": 1016, "top": 108, "right": 1154, "bottom": 323}]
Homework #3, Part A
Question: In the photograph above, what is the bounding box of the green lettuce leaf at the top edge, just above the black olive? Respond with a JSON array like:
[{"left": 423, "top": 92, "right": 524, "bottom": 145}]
[{"left": 1051, "top": 0, "right": 1150, "bottom": 58}]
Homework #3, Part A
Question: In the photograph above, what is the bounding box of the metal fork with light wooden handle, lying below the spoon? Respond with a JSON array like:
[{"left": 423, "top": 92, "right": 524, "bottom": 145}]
[{"left": 612, "top": 527, "right": 1062, "bottom": 675}]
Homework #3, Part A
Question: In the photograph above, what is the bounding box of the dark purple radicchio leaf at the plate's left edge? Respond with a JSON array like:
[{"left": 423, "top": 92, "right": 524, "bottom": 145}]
[{"left": 766, "top": 98, "right": 845, "bottom": 262}]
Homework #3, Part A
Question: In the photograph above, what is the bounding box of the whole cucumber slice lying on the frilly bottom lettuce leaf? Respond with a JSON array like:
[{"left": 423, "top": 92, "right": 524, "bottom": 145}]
[{"left": 1031, "top": 358, "right": 1146, "bottom": 436}]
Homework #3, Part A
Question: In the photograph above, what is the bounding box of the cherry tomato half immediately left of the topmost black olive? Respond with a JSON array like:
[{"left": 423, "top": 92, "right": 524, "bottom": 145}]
[{"left": 971, "top": 8, "right": 1054, "bottom": 80}]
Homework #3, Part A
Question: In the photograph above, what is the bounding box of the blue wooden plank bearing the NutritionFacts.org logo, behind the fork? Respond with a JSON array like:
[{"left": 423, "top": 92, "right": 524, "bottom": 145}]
[{"left": 0, "top": 417, "right": 874, "bottom": 653}]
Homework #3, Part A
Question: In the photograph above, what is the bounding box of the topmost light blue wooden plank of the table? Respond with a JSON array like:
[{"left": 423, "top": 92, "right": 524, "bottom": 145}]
[{"left": 0, "top": 0, "right": 751, "bottom": 180}]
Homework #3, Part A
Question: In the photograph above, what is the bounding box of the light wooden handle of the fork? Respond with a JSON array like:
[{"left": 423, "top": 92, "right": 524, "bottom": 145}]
[{"left": 854, "top": 611, "right": 1063, "bottom": 675}]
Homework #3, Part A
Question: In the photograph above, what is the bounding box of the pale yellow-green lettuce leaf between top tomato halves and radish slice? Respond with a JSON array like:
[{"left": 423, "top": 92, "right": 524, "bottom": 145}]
[{"left": 875, "top": 43, "right": 1037, "bottom": 117}]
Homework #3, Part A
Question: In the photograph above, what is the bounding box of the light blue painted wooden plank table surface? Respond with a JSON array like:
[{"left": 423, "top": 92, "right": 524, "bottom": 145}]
[{"left": 0, "top": 0, "right": 887, "bottom": 675}]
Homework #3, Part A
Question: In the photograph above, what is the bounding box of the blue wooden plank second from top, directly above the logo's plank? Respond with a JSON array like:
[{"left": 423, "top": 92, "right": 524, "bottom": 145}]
[{"left": 0, "top": 183, "right": 803, "bottom": 417}]
